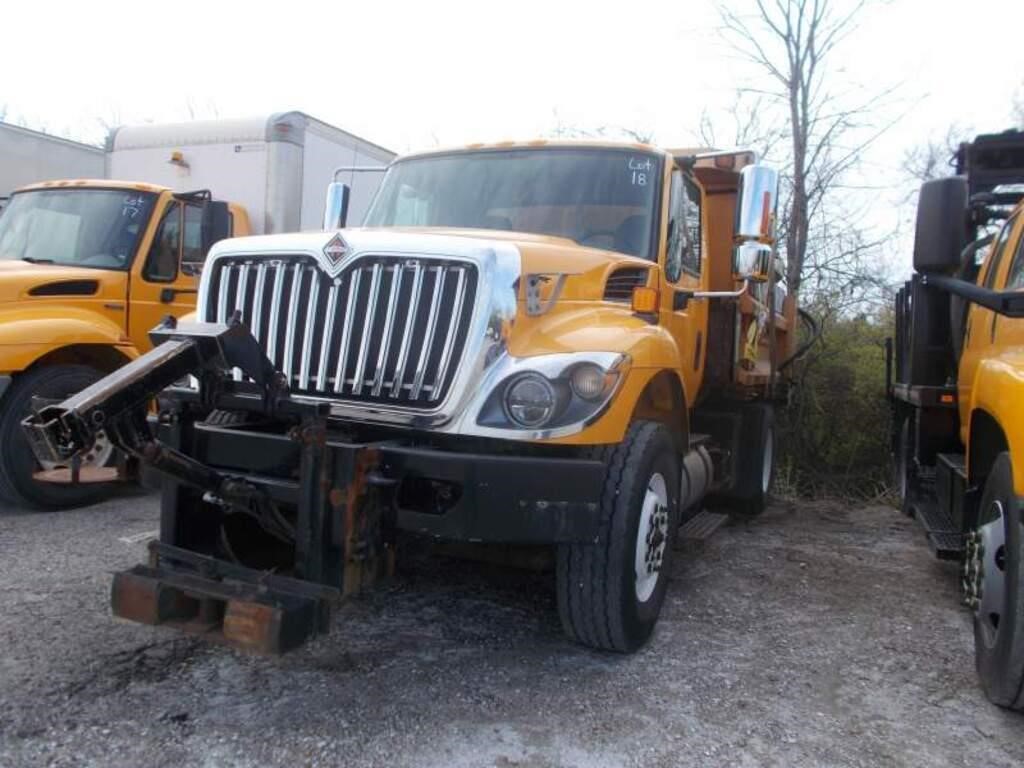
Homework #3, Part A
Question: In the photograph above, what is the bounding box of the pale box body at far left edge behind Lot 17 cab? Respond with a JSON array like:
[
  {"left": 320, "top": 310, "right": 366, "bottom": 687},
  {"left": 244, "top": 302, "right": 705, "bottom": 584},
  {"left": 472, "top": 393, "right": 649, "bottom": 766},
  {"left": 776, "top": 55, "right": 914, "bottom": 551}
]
[{"left": 0, "top": 123, "right": 105, "bottom": 196}]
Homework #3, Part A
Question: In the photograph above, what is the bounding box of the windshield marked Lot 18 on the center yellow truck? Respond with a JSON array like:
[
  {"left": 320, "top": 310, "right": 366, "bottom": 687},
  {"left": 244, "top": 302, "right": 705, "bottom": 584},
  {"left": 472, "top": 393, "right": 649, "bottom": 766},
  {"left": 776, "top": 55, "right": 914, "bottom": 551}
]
[{"left": 364, "top": 148, "right": 662, "bottom": 260}]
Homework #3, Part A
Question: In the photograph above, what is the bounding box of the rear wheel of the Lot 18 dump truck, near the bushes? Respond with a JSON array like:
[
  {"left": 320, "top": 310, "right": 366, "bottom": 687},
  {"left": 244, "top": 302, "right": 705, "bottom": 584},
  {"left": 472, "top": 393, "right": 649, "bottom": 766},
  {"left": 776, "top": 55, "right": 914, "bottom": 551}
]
[{"left": 728, "top": 402, "right": 775, "bottom": 517}]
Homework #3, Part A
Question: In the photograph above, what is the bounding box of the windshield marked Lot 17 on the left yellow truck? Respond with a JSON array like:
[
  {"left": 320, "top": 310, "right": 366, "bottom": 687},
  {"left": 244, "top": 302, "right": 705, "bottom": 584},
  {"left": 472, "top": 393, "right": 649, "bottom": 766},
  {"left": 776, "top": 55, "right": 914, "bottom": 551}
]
[{"left": 0, "top": 188, "right": 155, "bottom": 269}]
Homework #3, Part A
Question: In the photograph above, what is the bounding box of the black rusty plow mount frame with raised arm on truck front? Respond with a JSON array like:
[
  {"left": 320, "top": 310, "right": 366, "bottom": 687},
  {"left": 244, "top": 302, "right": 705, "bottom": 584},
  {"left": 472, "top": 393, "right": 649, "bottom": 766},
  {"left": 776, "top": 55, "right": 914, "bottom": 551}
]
[{"left": 23, "top": 318, "right": 393, "bottom": 653}]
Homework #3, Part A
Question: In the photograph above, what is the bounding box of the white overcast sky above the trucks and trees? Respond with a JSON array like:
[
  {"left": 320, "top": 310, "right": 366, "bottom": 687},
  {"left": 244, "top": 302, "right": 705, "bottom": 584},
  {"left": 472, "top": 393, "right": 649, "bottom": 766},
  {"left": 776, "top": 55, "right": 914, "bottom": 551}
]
[{"left": 0, "top": 0, "right": 1024, "bottom": 270}]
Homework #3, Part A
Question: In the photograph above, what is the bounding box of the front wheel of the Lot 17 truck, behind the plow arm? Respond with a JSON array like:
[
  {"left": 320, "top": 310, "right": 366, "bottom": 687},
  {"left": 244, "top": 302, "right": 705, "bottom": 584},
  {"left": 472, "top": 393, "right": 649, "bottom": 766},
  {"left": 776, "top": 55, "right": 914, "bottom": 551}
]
[{"left": 0, "top": 366, "right": 114, "bottom": 509}]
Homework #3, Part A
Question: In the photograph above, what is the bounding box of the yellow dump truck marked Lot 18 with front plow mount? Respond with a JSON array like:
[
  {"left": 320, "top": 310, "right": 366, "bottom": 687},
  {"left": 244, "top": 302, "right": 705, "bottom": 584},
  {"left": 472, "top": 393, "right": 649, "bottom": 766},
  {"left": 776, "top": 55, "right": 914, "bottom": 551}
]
[{"left": 26, "top": 141, "right": 798, "bottom": 652}]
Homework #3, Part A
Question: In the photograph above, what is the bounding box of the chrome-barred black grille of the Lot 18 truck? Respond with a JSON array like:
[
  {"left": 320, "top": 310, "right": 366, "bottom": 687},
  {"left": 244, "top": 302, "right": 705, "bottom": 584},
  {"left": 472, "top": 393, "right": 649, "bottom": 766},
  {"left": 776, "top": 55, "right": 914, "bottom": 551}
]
[{"left": 203, "top": 256, "right": 477, "bottom": 410}]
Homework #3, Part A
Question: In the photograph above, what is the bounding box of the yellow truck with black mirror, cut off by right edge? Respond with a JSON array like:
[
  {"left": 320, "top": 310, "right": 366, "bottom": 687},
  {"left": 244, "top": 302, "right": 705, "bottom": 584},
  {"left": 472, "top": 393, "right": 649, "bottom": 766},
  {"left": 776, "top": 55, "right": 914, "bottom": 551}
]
[{"left": 889, "top": 131, "right": 1024, "bottom": 712}]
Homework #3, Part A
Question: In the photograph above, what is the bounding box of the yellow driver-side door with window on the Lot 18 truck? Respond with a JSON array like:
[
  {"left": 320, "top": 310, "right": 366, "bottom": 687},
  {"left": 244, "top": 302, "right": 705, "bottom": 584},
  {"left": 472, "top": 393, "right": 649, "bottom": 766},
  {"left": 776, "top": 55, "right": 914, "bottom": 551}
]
[{"left": 660, "top": 168, "right": 708, "bottom": 398}]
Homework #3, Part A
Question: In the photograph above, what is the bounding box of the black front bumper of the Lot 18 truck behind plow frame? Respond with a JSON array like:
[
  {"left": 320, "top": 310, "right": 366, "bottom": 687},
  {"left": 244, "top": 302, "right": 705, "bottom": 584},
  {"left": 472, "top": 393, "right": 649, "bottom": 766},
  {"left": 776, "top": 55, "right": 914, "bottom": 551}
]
[{"left": 182, "top": 415, "right": 604, "bottom": 544}]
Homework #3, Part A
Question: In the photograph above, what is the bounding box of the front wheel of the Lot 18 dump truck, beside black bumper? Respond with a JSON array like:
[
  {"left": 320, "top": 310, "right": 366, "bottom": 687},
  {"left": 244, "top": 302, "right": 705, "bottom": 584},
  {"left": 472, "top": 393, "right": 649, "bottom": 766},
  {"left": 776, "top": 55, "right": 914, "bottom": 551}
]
[{"left": 556, "top": 421, "right": 680, "bottom": 653}]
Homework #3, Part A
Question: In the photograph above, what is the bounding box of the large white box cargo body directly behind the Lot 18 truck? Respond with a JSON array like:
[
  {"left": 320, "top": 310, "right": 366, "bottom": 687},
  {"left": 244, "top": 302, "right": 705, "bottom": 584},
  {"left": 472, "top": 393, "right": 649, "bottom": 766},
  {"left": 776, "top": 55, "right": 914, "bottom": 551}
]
[{"left": 106, "top": 112, "right": 394, "bottom": 233}]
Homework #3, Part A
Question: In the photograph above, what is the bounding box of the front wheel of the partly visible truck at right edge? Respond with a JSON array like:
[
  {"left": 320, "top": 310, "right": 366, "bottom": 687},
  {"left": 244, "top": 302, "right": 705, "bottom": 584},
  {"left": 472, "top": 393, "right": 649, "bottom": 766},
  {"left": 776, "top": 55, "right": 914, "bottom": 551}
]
[{"left": 965, "top": 453, "right": 1024, "bottom": 712}]
